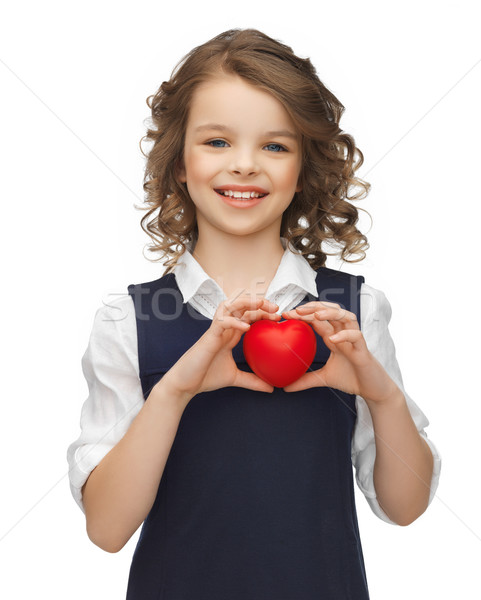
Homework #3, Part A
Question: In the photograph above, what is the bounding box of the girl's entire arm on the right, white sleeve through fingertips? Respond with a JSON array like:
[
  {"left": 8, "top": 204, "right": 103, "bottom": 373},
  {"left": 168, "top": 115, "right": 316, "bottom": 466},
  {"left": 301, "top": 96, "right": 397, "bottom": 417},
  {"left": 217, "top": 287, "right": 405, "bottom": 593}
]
[{"left": 285, "top": 286, "right": 440, "bottom": 525}]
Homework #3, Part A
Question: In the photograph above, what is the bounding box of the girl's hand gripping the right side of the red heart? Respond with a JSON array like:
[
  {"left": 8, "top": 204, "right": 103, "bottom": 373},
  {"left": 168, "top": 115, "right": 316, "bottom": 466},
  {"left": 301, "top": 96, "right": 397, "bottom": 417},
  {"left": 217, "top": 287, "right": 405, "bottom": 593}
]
[{"left": 282, "top": 302, "right": 399, "bottom": 402}]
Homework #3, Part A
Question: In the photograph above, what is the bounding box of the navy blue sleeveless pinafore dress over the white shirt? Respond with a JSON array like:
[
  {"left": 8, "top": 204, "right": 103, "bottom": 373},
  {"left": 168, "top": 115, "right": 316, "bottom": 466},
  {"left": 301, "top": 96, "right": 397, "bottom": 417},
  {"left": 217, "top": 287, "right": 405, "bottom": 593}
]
[{"left": 127, "top": 267, "right": 369, "bottom": 600}]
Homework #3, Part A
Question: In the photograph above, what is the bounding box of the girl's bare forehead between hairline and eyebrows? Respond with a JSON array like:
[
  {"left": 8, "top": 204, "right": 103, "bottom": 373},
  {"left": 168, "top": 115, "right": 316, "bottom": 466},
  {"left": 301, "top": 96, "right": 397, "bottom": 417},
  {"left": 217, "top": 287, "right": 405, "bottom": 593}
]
[{"left": 188, "top": 75, "right": 296, "bottom": 131}]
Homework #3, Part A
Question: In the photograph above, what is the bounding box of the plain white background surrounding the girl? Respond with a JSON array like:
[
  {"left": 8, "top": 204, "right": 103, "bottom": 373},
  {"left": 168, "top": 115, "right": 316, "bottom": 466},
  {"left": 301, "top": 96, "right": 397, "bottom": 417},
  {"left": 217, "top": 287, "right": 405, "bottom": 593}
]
[{"left": 0, "top": 0, "right": 481, "bottom": 600}]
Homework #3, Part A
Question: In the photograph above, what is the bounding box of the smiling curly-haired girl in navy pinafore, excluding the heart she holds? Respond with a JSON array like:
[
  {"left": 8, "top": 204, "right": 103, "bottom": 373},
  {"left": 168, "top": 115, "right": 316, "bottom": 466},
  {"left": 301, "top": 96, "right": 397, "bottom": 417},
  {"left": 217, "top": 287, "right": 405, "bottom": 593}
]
[{"left": 68, "top": 29, "right": 440, "bottom": 600}]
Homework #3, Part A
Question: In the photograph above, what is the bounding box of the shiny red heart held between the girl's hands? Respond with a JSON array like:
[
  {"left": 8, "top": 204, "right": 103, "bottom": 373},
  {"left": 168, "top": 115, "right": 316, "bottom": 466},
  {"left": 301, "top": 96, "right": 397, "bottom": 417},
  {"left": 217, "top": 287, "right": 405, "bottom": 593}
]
[{"left": 243, "top": 319, "right": 317, "bottom": 387}]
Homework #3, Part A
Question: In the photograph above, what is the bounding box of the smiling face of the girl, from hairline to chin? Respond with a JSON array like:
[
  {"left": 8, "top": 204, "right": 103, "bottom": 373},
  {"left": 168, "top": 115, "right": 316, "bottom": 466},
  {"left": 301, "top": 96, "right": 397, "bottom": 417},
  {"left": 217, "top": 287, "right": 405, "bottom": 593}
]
[{"left": 178, "top": 75, "right": 301, "bottom": 239}]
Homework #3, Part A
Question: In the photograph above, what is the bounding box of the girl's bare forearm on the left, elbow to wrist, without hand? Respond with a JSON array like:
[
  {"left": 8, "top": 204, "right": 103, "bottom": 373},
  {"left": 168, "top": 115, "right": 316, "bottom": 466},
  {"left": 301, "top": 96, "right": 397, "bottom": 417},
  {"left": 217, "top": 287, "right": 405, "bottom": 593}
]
[{"left": 83, "top": 379, "right": 187, "bottom": 552}]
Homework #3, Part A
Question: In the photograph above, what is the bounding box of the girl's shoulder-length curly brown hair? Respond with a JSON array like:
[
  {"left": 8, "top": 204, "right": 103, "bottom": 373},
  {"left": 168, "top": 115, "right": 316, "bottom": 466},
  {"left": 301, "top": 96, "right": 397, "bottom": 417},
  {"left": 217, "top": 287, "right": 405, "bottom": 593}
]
[{"left": 136, "top": 29, "right": 371, "bottom": 274}]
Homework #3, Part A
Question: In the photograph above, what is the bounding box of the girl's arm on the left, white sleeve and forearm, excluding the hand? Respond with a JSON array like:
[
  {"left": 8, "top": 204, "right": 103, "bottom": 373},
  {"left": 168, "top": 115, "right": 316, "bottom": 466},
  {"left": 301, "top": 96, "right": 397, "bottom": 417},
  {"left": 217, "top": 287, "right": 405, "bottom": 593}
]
[{"left": 67, "top": 295, "right": 189, "bottom": 552}]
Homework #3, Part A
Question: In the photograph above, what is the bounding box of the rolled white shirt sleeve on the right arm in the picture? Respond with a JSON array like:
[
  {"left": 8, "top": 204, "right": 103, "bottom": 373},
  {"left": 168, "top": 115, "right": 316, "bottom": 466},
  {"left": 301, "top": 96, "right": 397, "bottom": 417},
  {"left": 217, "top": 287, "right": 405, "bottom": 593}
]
[{"left": 352, "top": 283, "right": 441, "bottom": 525}]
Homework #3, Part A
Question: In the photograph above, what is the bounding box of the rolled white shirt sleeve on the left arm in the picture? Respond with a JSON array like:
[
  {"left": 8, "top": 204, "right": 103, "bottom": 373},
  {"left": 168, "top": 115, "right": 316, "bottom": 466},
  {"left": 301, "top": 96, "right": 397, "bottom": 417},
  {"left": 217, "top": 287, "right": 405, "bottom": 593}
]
[{"left": 67, "top": 294, "right": 144, "bottom": 512}]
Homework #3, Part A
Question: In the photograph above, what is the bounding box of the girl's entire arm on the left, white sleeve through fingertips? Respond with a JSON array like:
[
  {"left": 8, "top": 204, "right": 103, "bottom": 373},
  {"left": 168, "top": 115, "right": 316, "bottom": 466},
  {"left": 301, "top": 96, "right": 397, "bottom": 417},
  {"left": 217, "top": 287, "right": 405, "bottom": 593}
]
[{"left": 73, "top": 296, "right": 278, "bottom": 552}]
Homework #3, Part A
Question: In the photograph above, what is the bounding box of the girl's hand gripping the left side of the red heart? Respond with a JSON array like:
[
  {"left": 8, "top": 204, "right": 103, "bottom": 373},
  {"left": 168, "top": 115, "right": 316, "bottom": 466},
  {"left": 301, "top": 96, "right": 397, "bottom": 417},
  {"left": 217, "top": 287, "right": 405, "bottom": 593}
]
[{"left": 159, "top": 292, "right": 282, "bottom": 402}]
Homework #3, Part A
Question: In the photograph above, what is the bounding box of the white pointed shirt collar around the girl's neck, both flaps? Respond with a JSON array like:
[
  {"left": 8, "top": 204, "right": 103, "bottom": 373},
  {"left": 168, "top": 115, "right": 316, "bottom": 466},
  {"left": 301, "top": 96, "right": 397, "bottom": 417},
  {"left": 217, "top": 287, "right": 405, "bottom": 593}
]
[{"left": 173, "top": 237, "right": 318, "bottom": 304}]
